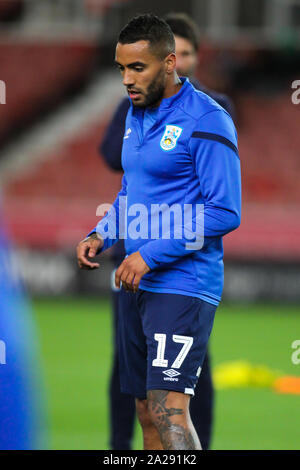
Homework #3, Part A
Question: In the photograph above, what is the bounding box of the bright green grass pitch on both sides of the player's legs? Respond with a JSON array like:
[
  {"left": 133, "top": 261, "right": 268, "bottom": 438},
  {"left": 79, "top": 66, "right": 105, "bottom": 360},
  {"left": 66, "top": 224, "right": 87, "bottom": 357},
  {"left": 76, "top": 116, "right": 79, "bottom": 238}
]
[{"left": 33, "top": 298, "right": 300, "bottom": 449}]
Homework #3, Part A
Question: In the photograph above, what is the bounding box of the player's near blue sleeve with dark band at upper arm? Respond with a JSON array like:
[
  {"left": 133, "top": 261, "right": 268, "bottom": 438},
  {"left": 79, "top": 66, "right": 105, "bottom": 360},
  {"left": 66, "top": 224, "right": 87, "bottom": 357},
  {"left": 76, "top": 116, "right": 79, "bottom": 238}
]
[{"left": 139, "top": 110, "right": 241, "bottom": 269}]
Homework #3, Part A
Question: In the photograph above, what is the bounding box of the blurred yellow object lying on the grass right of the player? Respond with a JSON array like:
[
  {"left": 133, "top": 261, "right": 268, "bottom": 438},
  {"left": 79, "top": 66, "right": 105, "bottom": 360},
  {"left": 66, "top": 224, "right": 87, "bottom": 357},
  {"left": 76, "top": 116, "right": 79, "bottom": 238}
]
[{"left": 213, "top": 360, "right": 282, "bottom": 390}]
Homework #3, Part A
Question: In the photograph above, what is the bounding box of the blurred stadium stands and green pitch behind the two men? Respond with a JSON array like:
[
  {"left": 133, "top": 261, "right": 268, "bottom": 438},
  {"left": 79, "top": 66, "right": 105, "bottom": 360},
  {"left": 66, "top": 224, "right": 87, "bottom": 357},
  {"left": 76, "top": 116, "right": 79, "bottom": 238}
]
[{"left": 0, "top": 0, "right": 300, "bottom": 449}]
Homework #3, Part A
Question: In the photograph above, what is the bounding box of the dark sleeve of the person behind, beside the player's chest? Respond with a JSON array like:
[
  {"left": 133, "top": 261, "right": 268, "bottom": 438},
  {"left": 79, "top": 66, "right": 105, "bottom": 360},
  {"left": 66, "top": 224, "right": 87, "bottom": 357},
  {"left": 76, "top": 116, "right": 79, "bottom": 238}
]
[{"left": 99, "top": 98, "right": 130, "bottom": 171}]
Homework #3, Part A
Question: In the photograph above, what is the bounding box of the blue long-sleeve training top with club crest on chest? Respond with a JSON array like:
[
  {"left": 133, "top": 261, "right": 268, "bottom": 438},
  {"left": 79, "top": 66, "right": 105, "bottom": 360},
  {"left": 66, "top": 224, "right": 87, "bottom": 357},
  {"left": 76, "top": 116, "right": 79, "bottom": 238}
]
[{"left": 91, "top": 78, "right": 241, "bottom": 305}]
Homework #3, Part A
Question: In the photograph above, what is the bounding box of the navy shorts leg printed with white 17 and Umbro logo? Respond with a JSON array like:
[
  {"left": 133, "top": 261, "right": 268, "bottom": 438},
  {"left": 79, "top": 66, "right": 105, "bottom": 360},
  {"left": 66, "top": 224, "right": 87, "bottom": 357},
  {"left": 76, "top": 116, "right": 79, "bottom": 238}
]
[{"left": 137, "top": 291, "right": 216, "bottom": 395}]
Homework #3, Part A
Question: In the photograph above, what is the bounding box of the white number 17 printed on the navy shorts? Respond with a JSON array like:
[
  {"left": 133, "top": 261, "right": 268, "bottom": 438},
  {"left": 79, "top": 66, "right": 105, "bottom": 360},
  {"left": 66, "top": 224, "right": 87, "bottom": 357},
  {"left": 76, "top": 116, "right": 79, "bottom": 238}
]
[{"left": 152, "top": 333, "right": 194, "bottom": 369}]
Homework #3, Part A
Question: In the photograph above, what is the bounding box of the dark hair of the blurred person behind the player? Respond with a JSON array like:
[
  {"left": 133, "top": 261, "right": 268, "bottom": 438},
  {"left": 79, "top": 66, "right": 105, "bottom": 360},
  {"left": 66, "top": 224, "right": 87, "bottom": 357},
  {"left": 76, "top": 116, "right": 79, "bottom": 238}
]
[{"left": 165, "top": 13, "right": 200, "bottom": 51}]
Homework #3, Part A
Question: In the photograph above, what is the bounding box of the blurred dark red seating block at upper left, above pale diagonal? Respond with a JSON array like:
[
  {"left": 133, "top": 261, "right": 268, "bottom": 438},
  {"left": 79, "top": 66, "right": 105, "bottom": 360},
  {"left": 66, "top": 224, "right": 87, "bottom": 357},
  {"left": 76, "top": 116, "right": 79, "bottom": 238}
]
[{"left": 0, "top": 41, "right": 97, "bottom": 144}]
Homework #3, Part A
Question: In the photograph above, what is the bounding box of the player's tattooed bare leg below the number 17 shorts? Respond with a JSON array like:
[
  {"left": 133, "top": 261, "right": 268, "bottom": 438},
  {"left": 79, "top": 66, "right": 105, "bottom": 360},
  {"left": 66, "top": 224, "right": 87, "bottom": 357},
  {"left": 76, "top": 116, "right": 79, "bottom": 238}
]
[{"left": 148, "top": 390, "right": 199, "bottom": 450}]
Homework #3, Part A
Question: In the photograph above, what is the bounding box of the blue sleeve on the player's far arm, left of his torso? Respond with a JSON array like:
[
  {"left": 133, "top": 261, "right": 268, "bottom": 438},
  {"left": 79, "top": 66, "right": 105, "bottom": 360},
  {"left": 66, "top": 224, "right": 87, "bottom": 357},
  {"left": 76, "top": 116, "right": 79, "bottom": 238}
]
[{"left": 88, "top": 175, "right": 127, "bottom": 252}]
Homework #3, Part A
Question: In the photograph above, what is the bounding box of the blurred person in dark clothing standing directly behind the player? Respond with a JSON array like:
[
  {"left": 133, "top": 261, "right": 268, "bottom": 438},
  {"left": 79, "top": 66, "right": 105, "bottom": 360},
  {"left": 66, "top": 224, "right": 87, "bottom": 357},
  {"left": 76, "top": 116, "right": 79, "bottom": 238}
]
[{"left": 100, "top": 13, "right": 233, "bottom": 450}]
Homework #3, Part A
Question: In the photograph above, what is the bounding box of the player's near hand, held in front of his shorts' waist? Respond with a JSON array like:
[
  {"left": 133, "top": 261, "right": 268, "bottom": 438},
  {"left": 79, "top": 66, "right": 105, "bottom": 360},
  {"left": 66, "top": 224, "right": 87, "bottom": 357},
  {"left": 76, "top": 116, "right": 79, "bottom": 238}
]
[{"left": 115, "top": 251, "right": 150, "bottom": 292}]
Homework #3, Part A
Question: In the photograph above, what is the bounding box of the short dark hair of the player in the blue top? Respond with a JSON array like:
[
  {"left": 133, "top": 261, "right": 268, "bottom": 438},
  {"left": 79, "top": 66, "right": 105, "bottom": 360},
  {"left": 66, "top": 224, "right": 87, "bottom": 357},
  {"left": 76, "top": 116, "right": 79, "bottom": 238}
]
[{"left": 118, "top": 13, "right": 175, "bottom": 59}]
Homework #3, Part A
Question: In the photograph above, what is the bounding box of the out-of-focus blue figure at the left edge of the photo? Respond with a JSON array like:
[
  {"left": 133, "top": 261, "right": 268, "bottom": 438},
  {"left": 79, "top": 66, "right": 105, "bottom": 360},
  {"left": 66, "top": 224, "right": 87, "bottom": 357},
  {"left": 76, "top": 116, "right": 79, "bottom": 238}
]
[{"left": 0, "top": 201, "right": 45, "bottom": 450}]
